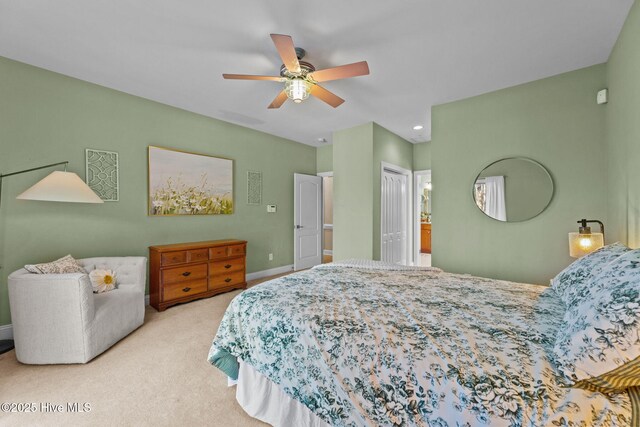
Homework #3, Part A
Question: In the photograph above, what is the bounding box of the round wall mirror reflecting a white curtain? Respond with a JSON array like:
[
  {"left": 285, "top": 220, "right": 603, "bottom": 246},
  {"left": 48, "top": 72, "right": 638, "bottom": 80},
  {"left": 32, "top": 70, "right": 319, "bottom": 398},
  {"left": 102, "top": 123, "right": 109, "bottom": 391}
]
[{"left": 473, "top": 157, "right": 553, "bottom": 222}]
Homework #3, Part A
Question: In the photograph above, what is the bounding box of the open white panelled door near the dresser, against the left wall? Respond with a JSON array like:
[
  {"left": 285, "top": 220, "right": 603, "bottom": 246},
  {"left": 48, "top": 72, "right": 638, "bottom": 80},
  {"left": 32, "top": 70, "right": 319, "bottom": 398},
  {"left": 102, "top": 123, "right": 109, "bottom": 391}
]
[{"left": 293, "top": 173, "right": 322, "bottom": 271}]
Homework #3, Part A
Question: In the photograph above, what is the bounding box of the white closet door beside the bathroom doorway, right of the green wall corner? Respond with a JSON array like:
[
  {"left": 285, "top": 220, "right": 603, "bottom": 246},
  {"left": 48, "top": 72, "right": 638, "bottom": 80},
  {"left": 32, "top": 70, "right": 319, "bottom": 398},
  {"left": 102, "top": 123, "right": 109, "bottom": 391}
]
[{"left": 380, "top": 169, "right": 408, "bottom": 264}]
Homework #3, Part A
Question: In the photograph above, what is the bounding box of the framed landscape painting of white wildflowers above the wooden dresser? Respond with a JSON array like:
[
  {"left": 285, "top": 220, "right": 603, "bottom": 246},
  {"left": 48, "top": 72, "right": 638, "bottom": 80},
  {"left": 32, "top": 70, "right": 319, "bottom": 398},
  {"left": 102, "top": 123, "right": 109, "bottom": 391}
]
[{"left": 149, "top": 146, "right": 233, "bottom": 216}]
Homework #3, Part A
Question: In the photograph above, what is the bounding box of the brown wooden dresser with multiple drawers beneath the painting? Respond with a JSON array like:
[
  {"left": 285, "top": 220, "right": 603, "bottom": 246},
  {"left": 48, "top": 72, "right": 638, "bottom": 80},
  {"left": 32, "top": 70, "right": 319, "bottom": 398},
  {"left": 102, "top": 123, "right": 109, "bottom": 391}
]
[{"left": 149, "top": 240, "right": 247, "bottom": 311}]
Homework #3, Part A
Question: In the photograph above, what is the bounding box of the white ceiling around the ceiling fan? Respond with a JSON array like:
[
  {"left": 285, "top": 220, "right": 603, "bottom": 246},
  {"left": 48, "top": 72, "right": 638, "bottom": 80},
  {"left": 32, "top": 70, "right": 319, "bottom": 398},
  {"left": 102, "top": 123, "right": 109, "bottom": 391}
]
[{"left": 0, "top": 0, "right": 633, "bottom": 145}]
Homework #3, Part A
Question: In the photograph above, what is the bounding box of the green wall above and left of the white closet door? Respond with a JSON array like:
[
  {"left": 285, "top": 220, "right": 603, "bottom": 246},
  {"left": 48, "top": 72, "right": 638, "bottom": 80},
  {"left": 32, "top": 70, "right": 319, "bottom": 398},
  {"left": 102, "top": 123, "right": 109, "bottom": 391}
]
[{"left": 373, "top": 123, "right": 413, "bottom": 260}]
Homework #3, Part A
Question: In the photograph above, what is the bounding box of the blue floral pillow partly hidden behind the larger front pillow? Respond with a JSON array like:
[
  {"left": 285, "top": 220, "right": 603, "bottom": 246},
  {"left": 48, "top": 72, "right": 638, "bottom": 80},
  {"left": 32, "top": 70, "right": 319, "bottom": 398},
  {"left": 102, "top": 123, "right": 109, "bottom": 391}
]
[{"left": 551, "top": 243, "right": 631, "bottom": 306}]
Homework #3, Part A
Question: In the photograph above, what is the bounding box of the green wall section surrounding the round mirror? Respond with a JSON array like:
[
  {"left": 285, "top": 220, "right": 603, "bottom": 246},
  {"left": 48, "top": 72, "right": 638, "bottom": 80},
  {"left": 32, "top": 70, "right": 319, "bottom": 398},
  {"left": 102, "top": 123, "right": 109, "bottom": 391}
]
[{"left": 432, "top": 65, "right": 608, "bottom": 284}]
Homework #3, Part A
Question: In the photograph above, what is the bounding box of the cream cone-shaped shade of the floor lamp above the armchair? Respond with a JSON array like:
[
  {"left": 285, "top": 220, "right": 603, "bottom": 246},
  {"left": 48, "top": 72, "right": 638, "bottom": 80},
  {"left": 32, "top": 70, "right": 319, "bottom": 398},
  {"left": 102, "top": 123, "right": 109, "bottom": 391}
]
[{"left": 16, "top": 171, "right": 104, "bottom": 203}]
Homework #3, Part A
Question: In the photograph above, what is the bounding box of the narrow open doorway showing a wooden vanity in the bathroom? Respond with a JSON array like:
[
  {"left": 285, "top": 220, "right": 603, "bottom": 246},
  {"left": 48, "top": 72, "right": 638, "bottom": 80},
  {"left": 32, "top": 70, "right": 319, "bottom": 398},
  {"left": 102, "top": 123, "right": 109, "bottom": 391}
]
[{"left": 413, "top": 170, "right": 433, "bottom": 267}]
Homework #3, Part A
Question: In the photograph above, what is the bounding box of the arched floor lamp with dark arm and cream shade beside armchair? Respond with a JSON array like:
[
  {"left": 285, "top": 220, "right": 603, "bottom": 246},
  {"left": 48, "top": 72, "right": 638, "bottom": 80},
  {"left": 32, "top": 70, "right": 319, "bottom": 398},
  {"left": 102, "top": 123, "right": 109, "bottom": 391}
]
[{"left": 0, "top": 161, "right": 104, "bottom": 354}]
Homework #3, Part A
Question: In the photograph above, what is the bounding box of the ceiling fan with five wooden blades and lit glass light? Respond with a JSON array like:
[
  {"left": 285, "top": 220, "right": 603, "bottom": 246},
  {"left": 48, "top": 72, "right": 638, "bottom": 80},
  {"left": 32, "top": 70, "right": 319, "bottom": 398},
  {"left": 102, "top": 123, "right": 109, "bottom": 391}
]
[{"left": 222, "top": 34, "right": 369, "bottom": 108}]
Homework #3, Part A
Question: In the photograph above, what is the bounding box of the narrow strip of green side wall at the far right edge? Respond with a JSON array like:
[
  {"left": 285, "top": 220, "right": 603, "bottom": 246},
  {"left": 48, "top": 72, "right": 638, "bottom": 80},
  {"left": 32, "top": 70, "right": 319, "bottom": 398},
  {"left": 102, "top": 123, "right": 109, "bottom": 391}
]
[{"left": 604, "top": 2, "right": 640, "bottom": 248}]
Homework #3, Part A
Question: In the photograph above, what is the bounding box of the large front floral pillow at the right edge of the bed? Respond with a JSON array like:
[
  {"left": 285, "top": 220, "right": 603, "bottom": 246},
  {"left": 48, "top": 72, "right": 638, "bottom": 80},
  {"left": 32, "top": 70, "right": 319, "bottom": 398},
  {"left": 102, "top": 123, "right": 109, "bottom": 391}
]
[{"left": 554, "top": 249, "right": 640, "bottom": 393}]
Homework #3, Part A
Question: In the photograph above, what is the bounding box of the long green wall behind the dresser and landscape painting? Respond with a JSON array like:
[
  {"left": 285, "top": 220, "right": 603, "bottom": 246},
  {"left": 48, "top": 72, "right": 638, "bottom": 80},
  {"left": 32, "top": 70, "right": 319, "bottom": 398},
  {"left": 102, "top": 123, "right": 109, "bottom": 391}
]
[{"left": 0, "top": 58, "right": 316, "bottom": 324}]
